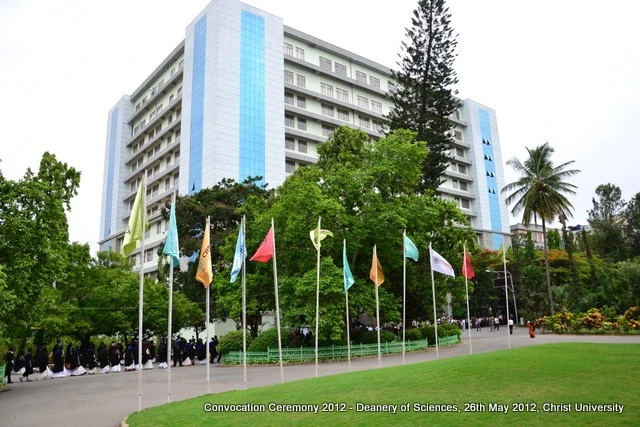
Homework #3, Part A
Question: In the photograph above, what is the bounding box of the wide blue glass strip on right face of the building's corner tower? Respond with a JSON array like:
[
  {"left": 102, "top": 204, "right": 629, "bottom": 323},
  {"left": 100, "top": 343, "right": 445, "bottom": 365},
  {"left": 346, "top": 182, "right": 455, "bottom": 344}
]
[{"left": 239, "top": 10, "right": 265, "bottom": 182}]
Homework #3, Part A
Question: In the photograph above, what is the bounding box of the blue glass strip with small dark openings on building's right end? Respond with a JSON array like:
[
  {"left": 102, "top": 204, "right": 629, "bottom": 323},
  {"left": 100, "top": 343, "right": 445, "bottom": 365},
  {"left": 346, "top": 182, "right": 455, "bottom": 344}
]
[{"left": 478, "top": 109, "right": 503, "bottom": 250}]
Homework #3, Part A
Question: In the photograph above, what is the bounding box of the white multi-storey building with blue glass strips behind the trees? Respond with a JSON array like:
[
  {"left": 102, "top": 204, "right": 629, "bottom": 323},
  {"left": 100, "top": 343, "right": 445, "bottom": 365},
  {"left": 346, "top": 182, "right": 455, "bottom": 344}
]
[{"left": 99, "top": 0, "right": 509, "bottom": 272}]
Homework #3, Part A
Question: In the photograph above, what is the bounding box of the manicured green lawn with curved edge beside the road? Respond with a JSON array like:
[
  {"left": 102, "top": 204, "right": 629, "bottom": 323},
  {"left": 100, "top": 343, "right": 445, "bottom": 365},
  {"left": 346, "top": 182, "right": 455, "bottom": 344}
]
[{"left": 129, "top": 343, "right": 640, "bottom": 427}]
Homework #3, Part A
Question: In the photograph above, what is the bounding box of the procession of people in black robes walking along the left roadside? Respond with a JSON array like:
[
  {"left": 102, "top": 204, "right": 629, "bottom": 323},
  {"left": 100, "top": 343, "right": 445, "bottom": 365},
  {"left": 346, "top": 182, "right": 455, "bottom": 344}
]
[{"left": 4, "top": 336, "right": 222, "bottom": 384}]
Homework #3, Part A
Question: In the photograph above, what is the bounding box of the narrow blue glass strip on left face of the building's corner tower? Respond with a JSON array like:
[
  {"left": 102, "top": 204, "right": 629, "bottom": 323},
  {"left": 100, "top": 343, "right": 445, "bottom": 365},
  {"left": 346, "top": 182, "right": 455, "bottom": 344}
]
[{"left": 188, "top": 15, "right": 207, "bottom": 195}]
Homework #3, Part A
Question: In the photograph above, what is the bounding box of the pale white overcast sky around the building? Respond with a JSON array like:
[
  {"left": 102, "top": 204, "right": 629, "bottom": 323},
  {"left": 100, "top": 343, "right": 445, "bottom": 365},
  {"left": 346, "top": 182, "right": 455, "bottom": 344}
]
[{"left": 0, "top": 0, "right": 640, "bottom": 251}]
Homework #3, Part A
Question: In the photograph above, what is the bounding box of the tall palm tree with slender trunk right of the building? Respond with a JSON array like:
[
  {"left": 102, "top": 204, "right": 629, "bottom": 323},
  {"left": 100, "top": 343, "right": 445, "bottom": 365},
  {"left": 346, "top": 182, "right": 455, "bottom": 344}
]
[{"left": 502, "top": 142, "right": 580, "bottom": 315}]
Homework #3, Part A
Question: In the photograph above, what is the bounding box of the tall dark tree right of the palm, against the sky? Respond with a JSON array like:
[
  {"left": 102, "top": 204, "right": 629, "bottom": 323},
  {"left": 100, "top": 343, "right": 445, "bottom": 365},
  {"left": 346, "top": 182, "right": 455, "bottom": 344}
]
[{"left": 588, "top": 184, "right": 628, "bottom": 262}]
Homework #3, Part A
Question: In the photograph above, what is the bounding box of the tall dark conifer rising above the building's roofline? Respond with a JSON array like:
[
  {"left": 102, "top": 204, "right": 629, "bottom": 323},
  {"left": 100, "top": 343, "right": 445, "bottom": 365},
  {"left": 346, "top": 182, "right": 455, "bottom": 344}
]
[{"left": 388, "top": 0, "right": 460, "bottom": 191}]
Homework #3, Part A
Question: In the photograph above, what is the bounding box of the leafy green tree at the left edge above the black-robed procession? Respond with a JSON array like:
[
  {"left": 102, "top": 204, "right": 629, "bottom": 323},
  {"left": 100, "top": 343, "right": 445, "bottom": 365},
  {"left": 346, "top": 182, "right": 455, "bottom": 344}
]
[{"left": 0, "top": 152, "right": 80, "bottom": 337}]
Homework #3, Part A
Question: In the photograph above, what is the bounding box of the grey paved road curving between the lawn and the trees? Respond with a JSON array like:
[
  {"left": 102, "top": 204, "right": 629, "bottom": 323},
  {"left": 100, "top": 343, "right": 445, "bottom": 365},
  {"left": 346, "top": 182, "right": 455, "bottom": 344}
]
[{"left": 0, "top": 328, "right": 640, "bottom": 427}]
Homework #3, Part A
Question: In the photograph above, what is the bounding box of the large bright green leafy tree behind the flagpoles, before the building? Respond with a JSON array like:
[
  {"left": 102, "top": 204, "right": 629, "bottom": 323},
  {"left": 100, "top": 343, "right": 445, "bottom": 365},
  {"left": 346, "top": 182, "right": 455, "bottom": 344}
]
[{"left": 216, "top": 127, "right": 474, "bottom": 342}]
